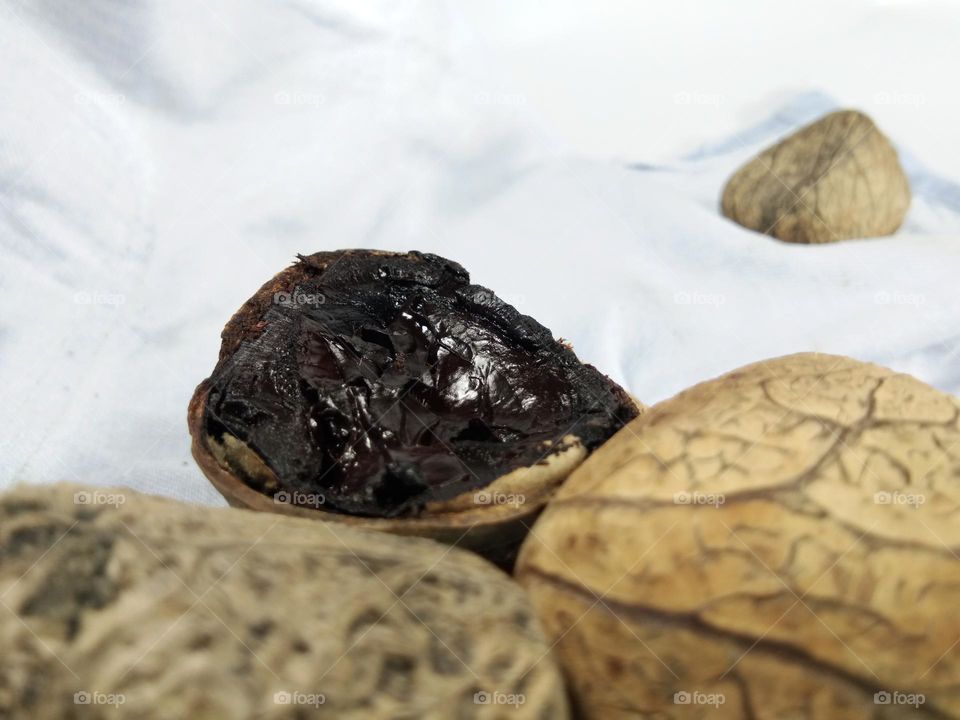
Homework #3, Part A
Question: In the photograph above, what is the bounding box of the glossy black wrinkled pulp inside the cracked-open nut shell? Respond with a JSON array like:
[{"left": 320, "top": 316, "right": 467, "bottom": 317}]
[{"left": 206, "top": 251, "right": 637, "bottom": 517}]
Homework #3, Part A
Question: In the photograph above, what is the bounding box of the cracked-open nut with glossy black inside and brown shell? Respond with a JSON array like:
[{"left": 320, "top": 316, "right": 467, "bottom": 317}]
[{"left": 189, "top": 250, "right": 638, "bottom": 563}]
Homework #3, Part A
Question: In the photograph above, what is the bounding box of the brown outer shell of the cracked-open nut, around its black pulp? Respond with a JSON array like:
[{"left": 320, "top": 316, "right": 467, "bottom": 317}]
[{"left": 187, "top": 251, "right": 643, "bottom": 565}]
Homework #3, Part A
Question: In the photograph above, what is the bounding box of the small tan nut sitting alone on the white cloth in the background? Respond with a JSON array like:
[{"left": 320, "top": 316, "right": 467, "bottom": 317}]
[{"left": 721, "top": 110, "right": 910, "bottom": 243}]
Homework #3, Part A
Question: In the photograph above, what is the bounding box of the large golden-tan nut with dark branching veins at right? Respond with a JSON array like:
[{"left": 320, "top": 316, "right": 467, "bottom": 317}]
[{"left": 517, "top": 354, "right": 960, "bottom": 720}]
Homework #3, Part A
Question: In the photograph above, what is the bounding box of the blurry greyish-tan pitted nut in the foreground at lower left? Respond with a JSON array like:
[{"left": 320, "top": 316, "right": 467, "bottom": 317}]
[{"left": 0, "top": 485, "right": 567, "bottom": 719}]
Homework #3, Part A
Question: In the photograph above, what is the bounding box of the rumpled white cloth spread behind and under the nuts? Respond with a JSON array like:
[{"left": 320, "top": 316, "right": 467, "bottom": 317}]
[{"left": 0, "top": 0, "right": 960, "bottom": 504}]
